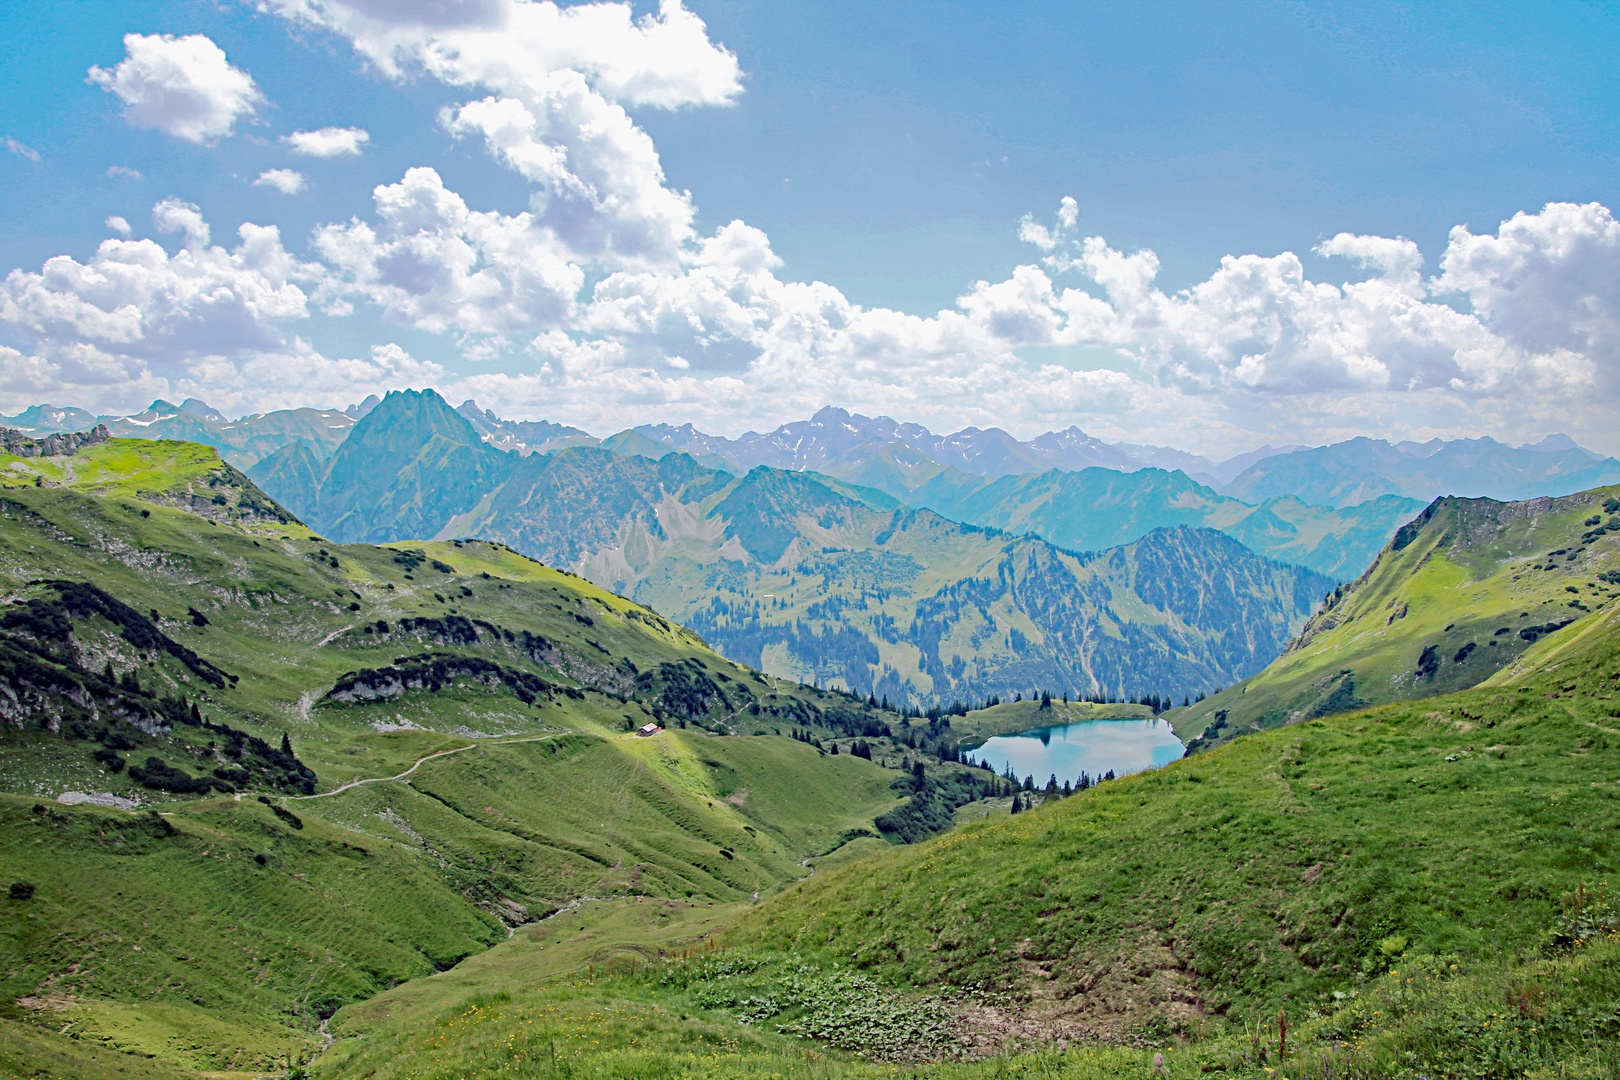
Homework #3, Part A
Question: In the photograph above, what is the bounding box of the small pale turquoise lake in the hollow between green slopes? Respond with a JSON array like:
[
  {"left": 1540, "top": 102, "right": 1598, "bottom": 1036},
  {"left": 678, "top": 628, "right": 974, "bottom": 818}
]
[{"left": 972, "top": 721, "right": 1186, "bottom": 787}]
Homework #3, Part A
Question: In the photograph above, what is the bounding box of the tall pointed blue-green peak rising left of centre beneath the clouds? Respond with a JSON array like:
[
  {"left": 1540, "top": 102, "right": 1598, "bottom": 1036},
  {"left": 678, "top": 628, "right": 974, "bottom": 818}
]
[{"left": 309, "top": 390, "right": 520, "bottom": 542}]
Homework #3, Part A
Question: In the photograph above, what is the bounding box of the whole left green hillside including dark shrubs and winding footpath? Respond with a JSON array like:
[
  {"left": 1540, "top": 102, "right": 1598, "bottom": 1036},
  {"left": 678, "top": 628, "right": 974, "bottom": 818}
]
[{"left": 0, "top": 459, "right": 939, "bottom": 1075}]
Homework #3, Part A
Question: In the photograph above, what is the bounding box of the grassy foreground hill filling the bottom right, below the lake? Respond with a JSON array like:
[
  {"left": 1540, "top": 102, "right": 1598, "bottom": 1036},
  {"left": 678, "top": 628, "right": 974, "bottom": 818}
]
[{"left": 285, "top": 550, "right": 1620, "bottom": 1080}]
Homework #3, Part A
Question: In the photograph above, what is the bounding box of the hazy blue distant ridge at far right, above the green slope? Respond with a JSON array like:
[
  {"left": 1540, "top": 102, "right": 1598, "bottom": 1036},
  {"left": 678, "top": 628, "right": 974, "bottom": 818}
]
[{"left": 1221, "top": 439, "right": 1620, "bottom": 507}]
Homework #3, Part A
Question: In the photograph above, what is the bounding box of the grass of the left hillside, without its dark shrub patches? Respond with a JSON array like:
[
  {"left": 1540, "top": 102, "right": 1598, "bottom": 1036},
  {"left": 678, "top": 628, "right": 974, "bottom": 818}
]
[{"left": 0, "top": 444, "right": 896, "bottom": 1069}]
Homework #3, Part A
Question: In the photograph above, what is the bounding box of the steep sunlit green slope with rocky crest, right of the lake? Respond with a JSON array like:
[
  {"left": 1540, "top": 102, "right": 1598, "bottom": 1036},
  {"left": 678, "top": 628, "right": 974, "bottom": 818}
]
[{"left": 1175, "top": 487, "right": 1620, "bottom": 745}]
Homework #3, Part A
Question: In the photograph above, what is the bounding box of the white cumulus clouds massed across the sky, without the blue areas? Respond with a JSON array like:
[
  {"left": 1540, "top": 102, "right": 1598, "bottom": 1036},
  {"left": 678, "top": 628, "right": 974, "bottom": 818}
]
[{"left": 0, "top": 0, "right": 1620, "bottom": 452}]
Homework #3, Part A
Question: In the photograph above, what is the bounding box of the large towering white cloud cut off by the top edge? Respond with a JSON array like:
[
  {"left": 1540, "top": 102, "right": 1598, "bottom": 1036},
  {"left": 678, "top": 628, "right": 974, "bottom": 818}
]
[{"left": 261, "top": 0, "right": 742, "bottom": 270}]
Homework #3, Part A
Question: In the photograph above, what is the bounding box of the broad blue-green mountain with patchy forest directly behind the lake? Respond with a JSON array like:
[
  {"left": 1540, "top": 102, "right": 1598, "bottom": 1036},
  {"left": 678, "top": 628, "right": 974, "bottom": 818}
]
[{"left": 457, "top": 447, "right": 1330, "bottom": 703}]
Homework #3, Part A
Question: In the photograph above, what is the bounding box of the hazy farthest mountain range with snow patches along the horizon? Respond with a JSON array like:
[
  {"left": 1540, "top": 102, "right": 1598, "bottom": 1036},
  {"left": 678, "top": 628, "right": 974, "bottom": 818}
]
[{"left": 0, "top": 395, "right": 1620, "bottom": 508}]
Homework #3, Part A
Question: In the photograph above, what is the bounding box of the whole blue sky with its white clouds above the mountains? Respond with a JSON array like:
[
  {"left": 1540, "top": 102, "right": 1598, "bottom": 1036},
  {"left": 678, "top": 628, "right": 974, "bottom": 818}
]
[{"left": 0, "top": 0, "right": 1620, "bottom": 457}]
